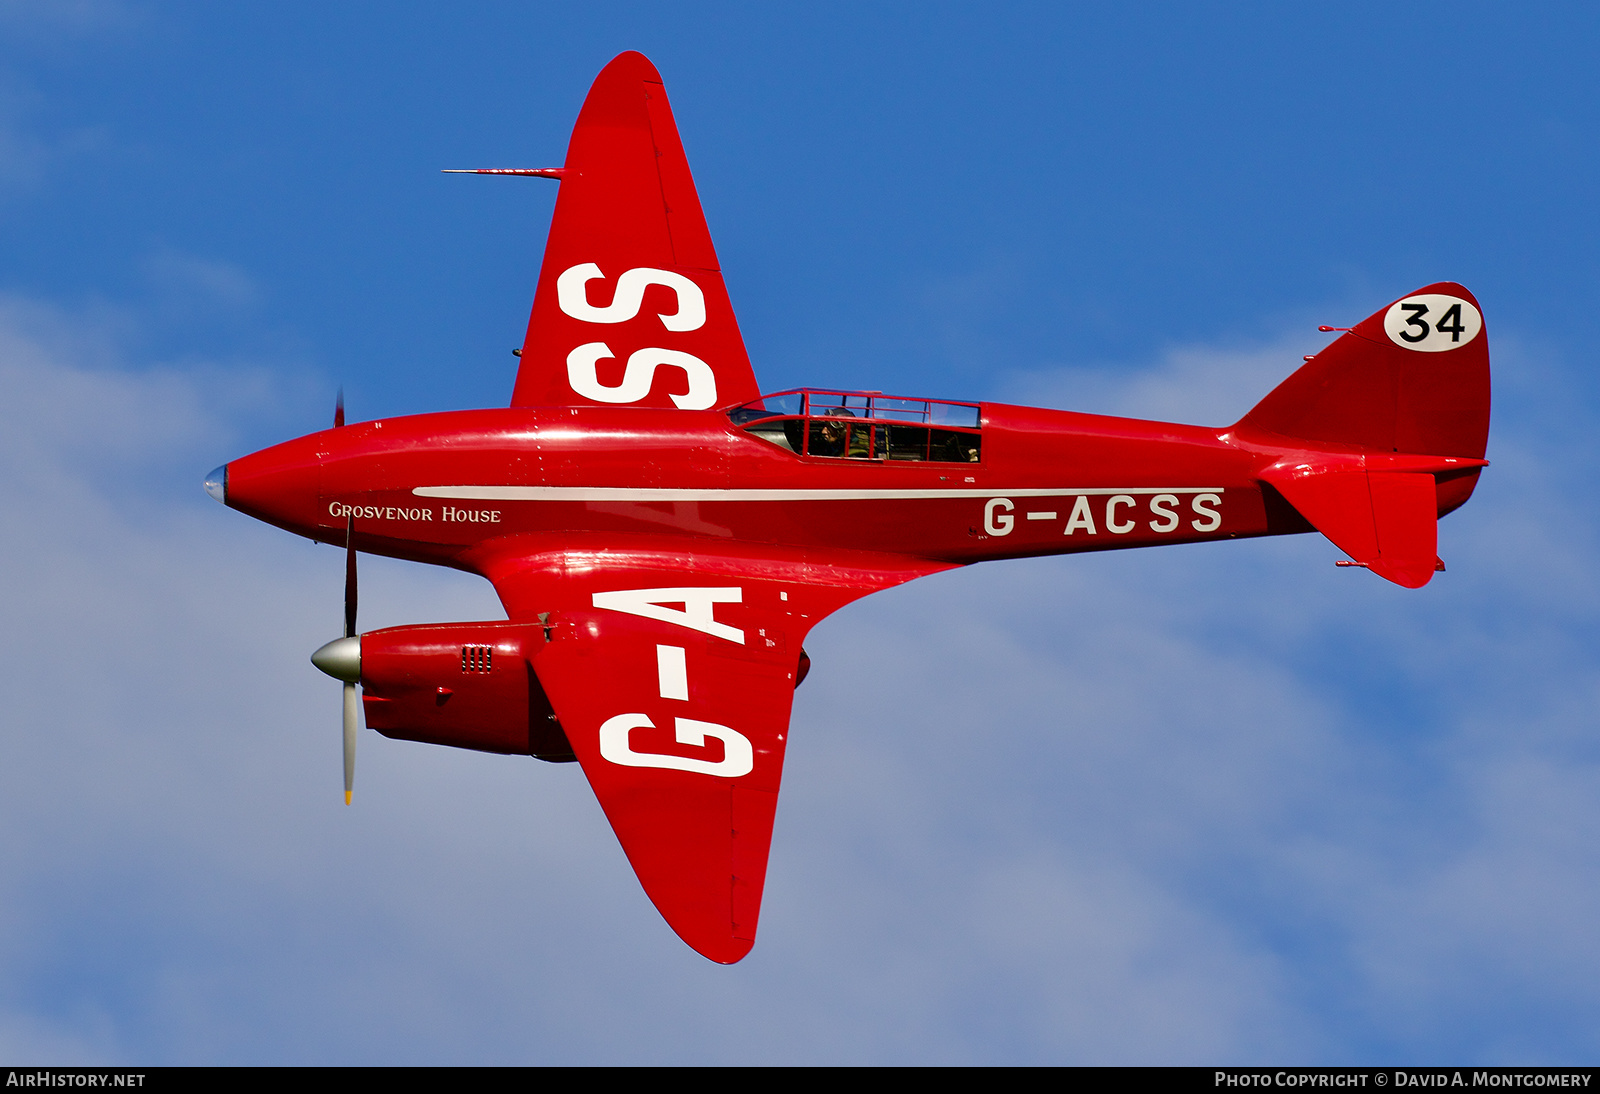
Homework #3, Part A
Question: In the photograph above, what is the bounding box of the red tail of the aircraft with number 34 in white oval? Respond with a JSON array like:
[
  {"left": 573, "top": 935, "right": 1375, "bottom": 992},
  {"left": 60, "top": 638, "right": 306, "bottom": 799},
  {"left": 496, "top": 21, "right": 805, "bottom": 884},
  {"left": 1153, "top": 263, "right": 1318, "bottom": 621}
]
[{"left": 1234, "top": 281, "right": 1490, "bottom": 589}]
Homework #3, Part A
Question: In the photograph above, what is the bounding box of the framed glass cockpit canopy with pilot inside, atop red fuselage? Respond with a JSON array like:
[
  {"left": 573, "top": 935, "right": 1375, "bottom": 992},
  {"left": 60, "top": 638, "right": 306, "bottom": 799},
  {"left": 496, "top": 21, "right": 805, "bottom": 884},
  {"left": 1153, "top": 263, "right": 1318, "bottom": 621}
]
[{"left": 728, "top": 387, "right": 982, "bottom": 464}]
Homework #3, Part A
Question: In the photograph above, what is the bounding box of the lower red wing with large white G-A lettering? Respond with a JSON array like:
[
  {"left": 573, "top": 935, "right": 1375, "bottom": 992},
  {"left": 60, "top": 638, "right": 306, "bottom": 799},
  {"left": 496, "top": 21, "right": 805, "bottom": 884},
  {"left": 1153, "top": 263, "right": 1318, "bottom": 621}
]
[{"left": 474, "top": 544, "right": 947, "bottom": 963}]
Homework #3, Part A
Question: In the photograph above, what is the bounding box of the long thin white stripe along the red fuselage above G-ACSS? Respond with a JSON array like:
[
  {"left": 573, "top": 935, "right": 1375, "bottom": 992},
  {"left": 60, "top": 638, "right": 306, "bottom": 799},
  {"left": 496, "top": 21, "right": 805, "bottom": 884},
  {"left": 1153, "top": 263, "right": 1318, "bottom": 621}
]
[{"left": 411, "top": 486, "right": 1227, "bottom": 502}]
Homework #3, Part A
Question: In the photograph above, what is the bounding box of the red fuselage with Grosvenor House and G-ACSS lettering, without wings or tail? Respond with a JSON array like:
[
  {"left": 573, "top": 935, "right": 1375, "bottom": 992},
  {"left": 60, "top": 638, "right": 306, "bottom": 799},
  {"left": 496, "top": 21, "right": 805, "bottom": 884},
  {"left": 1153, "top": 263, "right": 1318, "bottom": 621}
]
[{"left": 216, "top": 395, "right": 1472, "bottom": 571}]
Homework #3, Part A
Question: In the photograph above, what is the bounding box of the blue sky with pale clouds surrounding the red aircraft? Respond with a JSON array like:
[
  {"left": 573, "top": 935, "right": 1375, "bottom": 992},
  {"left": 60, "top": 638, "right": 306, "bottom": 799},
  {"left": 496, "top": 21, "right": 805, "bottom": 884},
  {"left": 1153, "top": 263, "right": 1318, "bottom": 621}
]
[{"left": 0, "top": 0, "right": 1600, "bottom": 1064}]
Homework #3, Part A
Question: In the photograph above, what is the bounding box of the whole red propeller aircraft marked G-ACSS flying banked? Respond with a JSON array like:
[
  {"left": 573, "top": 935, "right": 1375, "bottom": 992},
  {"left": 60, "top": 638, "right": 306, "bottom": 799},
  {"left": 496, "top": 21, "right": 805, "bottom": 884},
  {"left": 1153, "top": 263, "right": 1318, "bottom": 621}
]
[{"left": 206, "top": 53, "right": 1490, "bottom": 963}]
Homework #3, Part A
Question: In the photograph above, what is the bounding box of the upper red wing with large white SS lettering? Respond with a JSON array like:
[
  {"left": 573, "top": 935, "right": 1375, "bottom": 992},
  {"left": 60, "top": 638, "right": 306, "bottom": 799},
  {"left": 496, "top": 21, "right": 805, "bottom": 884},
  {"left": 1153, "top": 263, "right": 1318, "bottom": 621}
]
[{"left": 510, "top": 53, "right": 760, "bottom": 409}]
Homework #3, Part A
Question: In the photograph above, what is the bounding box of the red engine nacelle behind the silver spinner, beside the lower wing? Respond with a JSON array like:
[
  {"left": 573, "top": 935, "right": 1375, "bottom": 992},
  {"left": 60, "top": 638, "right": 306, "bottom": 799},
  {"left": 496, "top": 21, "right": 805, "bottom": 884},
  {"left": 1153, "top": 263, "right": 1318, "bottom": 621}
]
[{"left": 360, "top": 622, "right": 576, "bottom": 763}]
